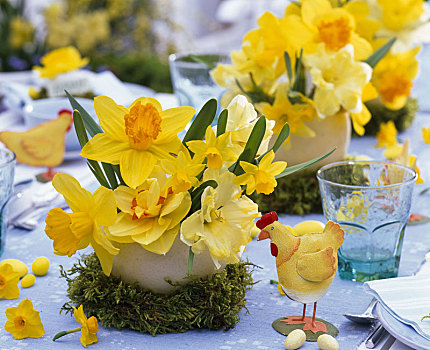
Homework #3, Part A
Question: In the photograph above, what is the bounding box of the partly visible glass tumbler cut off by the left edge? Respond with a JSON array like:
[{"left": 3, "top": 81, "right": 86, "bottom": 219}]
[{"left": 0, "top": 148, "right": 16, "bottom": 255}]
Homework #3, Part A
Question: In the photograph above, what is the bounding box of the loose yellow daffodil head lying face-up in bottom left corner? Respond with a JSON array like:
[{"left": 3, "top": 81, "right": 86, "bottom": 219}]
[{"left": 4, "top": 299, "right": 45, "bottom": 339}]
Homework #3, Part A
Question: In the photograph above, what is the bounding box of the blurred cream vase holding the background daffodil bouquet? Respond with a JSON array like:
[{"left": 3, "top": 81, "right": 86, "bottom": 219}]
[{"left": 272, "top": 112, "right": 351, "bottom": 171}]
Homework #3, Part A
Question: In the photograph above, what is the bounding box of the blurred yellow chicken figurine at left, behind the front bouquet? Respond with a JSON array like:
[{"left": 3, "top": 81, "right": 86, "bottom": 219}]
[{"left": 0, "top": 109, "right": 73, "bottom": 180}]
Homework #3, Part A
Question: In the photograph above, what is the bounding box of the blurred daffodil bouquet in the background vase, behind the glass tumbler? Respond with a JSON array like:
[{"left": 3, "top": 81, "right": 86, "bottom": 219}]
[{"left": 212, "top": 0, "right": 423, "bottom": 141}]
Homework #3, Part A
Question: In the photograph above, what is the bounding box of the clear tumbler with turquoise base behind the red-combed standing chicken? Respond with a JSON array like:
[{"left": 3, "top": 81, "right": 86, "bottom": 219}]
[{"left": 317, "top": 161, "right": 417, "bottom": 282}]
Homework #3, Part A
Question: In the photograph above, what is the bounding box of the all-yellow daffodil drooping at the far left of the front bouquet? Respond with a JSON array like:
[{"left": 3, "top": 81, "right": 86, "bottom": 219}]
[{"left": 45, "top": 173, "right": 119, "bottom": 275}]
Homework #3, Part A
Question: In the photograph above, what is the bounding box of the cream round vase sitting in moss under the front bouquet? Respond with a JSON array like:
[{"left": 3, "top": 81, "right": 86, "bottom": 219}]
[{"left": 112, "top": 234, "right": 225, "bottom": 294}]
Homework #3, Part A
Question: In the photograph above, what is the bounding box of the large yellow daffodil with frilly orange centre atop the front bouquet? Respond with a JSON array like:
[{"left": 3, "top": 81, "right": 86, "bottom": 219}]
[{"left": 81, "top": 96, "right": 195, "bottom": 188}]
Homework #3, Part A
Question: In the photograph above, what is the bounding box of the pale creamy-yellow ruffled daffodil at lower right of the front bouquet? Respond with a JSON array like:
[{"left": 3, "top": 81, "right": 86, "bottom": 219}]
[{"left": 181, "top": 171, "right": 259, "bottom": 268}]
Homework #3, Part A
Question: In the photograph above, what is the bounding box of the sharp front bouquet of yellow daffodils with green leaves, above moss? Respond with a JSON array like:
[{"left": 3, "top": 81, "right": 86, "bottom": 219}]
[{"left": 45, "top": 95, "right": 328, "bottom": 275}]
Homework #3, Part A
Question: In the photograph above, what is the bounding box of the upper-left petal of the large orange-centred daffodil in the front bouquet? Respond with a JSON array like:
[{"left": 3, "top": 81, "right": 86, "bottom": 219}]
[{"left": 94, "top": 96, "right": 128, "bottom": 142}]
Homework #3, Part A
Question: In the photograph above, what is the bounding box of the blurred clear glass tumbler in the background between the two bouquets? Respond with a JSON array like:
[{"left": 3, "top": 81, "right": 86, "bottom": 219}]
[{"left": 169, "top": 53, "right": 230, "bottom": 111}]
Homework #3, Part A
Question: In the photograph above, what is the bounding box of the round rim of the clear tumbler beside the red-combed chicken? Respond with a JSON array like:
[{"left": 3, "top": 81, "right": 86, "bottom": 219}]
[{"left": 317, "top": 160, "right": 417, "bottom": 190}]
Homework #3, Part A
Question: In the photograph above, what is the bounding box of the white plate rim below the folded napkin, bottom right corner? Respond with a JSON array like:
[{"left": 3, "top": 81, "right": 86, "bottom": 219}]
[{"left": 376, "top": 303, "right": 430, "bottom": 350}]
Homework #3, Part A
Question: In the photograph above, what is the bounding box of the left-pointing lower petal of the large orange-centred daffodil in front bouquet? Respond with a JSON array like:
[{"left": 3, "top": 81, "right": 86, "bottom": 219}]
[{"left": 81, "top": 133, "right": 130, "bottom": 164}]
